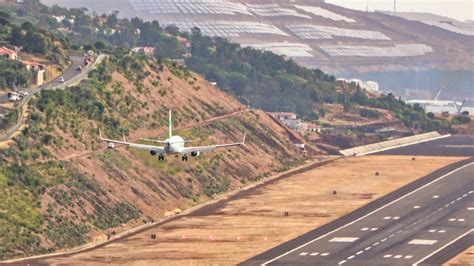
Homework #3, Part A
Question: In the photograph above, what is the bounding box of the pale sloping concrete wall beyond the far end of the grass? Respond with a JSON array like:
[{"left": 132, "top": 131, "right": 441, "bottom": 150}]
[{"left": 340, "top": 132, "right": 450, "bottom": 156}]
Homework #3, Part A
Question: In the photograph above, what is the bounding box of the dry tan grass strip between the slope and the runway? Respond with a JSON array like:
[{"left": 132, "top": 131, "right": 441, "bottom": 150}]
[{"left": 38, "top": 156, "right": 461, "bottom": 265}]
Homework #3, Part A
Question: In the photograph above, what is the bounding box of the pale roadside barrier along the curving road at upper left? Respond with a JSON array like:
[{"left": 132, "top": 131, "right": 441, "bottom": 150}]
[{"left": 0, "top": 54, "right": 109, "bottom": 142}]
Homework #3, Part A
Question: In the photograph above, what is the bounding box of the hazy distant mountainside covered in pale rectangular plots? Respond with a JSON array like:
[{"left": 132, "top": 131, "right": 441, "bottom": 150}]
[{"left": 43, "top": 0, "right": 474, "bottom": 73}]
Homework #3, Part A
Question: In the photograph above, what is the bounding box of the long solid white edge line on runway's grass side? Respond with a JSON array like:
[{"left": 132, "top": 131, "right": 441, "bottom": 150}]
[{"left": 262, "top": 163, "right": 474, "bottom": 265}]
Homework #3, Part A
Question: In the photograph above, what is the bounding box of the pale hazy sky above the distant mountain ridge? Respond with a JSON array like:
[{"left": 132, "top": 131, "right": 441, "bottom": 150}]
[{"left": 326, "top": 0, "right": 474, "bottom": 21}]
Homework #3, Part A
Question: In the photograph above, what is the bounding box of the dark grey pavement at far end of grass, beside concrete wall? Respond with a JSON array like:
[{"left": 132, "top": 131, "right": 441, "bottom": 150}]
[{"left": 375, "top": 135, "right": 474, "bottom": 157}]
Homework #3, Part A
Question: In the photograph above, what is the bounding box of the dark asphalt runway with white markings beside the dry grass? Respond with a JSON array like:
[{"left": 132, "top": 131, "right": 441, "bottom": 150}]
[{"left": 242, "top": 158, "right": 474, "bottom": 265}]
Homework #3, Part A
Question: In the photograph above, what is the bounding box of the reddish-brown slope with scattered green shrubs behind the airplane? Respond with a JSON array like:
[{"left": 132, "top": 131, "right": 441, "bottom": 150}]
[{"left": 0, "top": 56, "right": 303, "bottom": 259}]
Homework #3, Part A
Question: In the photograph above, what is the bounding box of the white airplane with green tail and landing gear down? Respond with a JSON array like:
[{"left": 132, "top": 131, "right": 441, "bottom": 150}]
[{"left": 99, "top": 110, "right": 246, "bottom": 161}]
